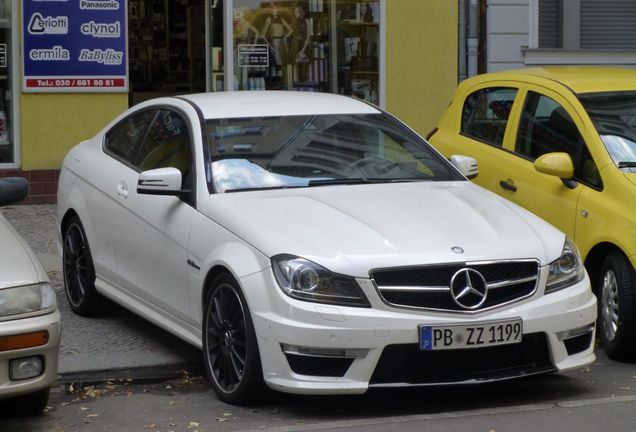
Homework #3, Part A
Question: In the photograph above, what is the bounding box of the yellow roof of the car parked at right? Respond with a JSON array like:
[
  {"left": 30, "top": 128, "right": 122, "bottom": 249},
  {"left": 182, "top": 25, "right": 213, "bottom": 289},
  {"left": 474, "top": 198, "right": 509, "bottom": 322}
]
[{"left": 476, "top": 66, "right": 636, "bottom": 93}]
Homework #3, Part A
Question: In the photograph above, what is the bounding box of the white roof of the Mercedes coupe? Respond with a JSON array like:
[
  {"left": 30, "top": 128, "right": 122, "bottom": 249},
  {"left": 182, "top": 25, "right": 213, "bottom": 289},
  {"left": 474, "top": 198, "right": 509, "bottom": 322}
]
[{"left": 180, "top": 90, "right": 380, "bottom": 119}]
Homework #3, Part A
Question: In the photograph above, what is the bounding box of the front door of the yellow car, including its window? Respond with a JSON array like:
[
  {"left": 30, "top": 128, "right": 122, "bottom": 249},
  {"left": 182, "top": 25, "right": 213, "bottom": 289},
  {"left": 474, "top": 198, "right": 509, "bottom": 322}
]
[{"left": 495, "top": 85, "right": 600, "bottom": 238}]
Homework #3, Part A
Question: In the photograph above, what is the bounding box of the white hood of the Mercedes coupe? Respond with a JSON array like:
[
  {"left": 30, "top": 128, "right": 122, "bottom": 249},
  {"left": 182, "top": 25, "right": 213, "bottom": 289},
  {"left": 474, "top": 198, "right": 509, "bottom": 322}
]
[{"left": 205, "top": 181, "right": 565, "bottom": 277}]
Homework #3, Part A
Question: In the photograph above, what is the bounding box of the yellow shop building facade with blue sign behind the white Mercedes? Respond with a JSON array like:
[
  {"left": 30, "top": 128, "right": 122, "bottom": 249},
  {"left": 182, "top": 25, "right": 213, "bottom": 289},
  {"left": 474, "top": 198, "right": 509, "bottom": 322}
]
[{"left": 0, "top": 0, "right": 458, "bottom": 203}]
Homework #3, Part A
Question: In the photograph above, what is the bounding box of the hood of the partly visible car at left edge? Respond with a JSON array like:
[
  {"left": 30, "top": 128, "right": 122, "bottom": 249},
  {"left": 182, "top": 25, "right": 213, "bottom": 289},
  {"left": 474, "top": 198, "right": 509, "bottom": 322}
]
[{"left": 0, "top": 213, "right": 44, "bottom": 289}]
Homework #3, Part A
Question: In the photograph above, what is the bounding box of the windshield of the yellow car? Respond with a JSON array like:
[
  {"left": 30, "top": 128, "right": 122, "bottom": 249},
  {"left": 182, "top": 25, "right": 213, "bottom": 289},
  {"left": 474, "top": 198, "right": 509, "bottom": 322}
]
[{"left": 578, "top": 91, "right": 636, "bottom": 171}]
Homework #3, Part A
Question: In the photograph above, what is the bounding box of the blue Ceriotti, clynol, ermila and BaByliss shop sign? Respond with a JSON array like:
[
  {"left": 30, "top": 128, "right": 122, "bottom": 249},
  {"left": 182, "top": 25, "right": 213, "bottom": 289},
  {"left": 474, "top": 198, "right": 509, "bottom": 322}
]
[{"left": 22, "top": 0, "right": 128, "bottom": 92}]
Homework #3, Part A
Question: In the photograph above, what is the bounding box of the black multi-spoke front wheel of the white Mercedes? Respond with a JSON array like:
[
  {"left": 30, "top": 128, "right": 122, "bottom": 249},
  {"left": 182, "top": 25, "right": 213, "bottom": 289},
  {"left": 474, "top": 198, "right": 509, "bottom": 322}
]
[{"left": 203, "top": 274, "right": 265, "bottom": 405}]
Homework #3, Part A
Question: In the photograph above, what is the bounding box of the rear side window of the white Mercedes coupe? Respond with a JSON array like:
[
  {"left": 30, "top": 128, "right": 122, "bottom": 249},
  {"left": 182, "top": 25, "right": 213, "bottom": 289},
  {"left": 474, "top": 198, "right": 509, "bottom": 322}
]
[{"left": 104, "top": 110, "right": 156, "bottom": 164}]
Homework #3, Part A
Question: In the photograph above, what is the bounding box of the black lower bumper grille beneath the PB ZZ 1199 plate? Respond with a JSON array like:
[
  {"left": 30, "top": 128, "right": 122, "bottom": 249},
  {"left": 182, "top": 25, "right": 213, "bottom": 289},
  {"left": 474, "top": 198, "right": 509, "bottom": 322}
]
[{"left": 369, "top": 333, "right": 555, "bottom": 386}]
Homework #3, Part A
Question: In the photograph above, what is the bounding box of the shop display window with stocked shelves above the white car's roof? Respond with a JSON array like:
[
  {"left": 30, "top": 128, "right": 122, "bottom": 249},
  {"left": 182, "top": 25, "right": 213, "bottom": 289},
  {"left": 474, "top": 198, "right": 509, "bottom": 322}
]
[{"left": 210, "top": 0, "right": 380, "bottom": 104}]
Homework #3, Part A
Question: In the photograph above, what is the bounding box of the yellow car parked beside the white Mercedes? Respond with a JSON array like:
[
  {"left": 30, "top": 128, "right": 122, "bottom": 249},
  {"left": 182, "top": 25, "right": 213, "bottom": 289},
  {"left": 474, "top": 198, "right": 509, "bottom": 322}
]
[{"left": 428, "top": 67, "right": 636, "bottom": 360}]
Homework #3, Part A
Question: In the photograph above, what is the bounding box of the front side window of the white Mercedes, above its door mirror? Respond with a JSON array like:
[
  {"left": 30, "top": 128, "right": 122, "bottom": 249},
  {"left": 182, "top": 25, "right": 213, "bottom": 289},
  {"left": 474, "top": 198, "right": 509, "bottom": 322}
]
[{"left": 133, "top": 109, "right": 192, "bottom": 176}]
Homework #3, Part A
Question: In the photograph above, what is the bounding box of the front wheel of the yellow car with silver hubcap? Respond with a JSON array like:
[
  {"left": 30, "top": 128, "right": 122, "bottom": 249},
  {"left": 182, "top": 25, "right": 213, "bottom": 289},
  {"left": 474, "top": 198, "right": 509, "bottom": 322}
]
[{"left": 597, "top": 252, "right": 636, "bottom": 361}]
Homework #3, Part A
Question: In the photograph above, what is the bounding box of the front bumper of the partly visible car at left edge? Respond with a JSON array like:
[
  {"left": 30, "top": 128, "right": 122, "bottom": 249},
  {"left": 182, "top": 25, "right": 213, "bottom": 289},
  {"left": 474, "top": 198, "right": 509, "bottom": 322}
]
[{"left": 0, "top": 309, "right": 62, "bottom": 398}]
